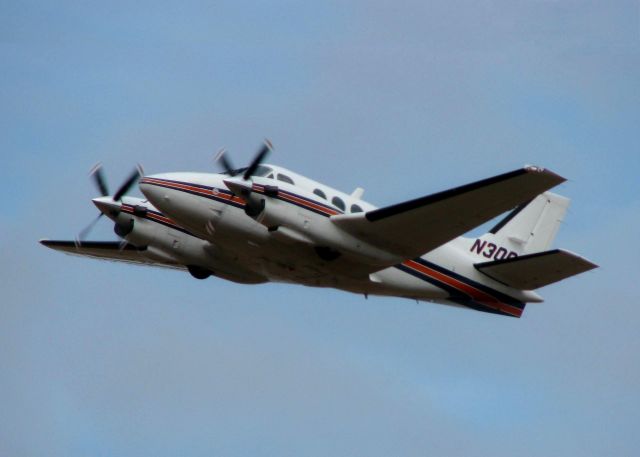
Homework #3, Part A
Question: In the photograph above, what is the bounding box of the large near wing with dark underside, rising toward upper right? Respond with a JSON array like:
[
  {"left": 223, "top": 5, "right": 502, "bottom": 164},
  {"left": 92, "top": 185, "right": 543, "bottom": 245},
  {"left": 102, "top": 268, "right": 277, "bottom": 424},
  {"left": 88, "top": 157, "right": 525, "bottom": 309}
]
[{"left": 331, "top": 167, "right": 565, "bottom": 259}]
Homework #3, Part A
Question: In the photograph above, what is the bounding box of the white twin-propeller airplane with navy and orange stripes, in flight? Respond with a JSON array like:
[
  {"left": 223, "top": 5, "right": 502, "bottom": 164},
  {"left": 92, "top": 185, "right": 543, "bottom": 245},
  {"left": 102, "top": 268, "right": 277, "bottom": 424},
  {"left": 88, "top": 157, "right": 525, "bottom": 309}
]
[{"left": 40, "top": 141, "right": 597, "bottom": 317}]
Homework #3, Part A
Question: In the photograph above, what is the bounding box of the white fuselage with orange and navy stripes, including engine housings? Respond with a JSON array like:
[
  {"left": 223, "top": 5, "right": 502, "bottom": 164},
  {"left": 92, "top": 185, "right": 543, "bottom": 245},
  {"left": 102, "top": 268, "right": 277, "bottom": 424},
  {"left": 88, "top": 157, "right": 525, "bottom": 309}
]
[{"left": 109, "top": 166, "right": 540, "bottom": 316}]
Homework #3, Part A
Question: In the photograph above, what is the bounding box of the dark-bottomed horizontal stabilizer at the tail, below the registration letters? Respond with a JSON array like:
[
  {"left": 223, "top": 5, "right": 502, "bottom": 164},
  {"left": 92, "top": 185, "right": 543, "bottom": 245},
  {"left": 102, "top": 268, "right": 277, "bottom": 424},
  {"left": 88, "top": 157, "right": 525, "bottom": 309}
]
[{"left": 475, "top": 249, "right": 598, "bottom": 290}]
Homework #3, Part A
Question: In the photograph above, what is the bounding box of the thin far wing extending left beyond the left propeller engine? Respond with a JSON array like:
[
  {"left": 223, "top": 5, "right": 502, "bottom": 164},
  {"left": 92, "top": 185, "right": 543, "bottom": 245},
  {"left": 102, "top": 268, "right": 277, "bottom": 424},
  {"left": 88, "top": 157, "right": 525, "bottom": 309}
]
[{"left": 40, "top": 240, "right": 185, "bottom": 270}]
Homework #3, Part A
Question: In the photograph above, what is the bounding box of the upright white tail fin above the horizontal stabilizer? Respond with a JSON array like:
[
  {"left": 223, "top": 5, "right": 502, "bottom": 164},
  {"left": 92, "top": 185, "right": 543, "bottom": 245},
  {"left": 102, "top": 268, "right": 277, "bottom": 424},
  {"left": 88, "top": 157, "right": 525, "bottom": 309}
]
[{"left": 482, "top": 192, "right": 570, "bottom": 255}]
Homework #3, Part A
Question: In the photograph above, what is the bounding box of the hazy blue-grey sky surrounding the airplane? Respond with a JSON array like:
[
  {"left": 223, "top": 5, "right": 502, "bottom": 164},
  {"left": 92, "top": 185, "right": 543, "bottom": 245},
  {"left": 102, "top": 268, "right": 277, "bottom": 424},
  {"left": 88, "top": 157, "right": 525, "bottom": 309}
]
[{"left": 0, "top": 1, "right": 640, "bottom": 457}]
